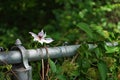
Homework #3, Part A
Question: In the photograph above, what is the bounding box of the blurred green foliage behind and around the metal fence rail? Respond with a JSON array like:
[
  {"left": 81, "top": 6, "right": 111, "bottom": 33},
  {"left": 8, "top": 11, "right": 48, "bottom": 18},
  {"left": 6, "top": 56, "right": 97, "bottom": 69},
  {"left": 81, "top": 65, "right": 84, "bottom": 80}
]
[{"left": 0, "top": 0, "right": 120, "bottom": 80}]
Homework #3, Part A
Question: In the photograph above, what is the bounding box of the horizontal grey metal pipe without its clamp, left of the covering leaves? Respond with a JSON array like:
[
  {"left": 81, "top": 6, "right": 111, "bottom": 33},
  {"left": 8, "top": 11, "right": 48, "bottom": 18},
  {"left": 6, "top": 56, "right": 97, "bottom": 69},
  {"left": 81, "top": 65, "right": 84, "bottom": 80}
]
[{"left": 0, "top": 45, "right": 80, "bottom": 65}]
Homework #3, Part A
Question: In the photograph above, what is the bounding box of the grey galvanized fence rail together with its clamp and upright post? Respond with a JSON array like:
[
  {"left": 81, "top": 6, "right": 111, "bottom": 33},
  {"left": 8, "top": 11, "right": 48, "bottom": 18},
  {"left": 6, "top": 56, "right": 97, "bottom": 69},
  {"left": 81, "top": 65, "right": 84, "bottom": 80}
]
[{"left": 0, "top": 39, "right": 118, "bottom": 80}]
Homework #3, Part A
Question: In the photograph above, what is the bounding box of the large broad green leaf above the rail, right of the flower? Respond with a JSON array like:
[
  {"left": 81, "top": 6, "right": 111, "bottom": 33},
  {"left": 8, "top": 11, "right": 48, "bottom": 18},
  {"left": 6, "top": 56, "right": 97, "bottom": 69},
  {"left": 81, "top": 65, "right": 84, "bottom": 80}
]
[{"left": 77, "top": 22, "right": 93, "bottom": 38}]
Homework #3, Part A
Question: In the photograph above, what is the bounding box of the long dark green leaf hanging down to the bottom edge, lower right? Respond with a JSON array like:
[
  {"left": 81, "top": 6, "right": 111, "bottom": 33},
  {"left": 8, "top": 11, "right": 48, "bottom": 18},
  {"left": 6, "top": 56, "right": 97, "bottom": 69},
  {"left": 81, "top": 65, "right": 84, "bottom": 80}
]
[{"left": 98, "top": 61, "right": 107, "bottom": 80}]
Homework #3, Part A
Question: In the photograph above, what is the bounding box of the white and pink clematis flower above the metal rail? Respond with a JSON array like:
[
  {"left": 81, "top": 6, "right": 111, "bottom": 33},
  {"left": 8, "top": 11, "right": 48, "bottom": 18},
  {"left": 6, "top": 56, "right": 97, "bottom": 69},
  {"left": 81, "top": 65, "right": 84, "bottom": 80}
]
[{"left": 29, "top": 30, "right": 53, "bottom": 44}]
